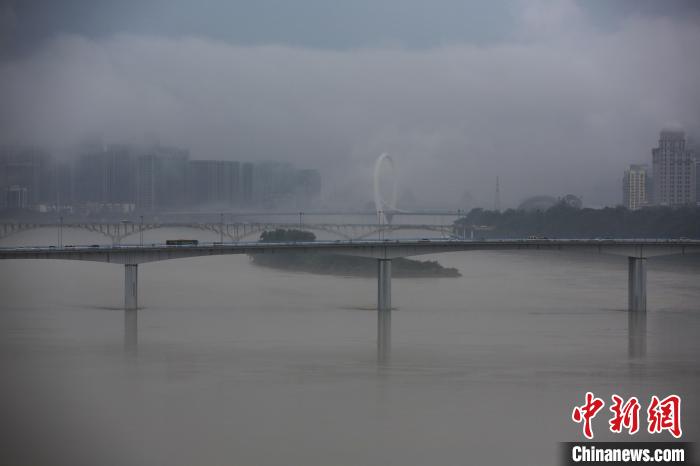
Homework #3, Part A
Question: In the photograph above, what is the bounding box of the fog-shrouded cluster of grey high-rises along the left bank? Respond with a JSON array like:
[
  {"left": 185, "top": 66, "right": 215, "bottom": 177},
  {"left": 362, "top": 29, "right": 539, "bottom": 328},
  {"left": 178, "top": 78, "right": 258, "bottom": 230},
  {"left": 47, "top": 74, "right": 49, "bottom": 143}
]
[{"left": 0, "top": 142, "right": 322, "bottom": 215}]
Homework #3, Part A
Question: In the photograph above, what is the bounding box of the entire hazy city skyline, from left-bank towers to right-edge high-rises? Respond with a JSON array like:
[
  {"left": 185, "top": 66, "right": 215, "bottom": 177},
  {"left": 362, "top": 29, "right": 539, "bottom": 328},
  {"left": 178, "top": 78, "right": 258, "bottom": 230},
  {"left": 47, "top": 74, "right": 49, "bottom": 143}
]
[{"left": 0, "top": 125, "right": 700, "bottom": 217}]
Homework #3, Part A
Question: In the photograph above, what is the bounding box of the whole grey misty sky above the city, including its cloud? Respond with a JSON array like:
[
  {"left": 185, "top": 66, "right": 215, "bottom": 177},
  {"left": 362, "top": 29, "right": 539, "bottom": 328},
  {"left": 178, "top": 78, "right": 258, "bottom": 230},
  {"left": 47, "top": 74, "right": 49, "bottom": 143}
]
[{"left": 0, "top": 0, "right": 700, "bottom": 208}]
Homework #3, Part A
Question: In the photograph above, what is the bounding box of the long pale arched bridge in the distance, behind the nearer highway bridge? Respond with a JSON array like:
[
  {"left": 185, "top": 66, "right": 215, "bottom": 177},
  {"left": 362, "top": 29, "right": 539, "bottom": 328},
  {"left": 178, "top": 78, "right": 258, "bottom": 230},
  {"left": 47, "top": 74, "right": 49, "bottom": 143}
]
[{"left": 0, "top": 222, "right": 489, "bottom": 246}]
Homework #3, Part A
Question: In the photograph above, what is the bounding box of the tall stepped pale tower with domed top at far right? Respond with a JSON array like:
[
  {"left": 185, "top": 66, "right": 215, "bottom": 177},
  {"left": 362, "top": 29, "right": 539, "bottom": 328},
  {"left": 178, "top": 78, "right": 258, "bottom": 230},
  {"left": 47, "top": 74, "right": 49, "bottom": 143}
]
[{"left": 652, "top": 130, "right": 697, "bottom": 206}]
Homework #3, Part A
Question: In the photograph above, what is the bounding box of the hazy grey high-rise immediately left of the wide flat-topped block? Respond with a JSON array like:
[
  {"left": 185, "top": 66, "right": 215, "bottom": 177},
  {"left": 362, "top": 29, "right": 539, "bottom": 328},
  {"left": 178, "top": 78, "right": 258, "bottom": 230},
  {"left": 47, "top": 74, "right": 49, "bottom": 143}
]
[{"left": 136, "top": 146, "right": 189, "bottom": 212}]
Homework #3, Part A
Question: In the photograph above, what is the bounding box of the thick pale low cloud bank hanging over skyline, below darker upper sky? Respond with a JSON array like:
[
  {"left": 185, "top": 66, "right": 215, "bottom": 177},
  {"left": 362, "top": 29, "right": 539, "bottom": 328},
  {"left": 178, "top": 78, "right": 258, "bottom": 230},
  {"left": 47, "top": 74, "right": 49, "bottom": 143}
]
[{"left": 0, "top": 10, "right": 700, "bottom": 208}]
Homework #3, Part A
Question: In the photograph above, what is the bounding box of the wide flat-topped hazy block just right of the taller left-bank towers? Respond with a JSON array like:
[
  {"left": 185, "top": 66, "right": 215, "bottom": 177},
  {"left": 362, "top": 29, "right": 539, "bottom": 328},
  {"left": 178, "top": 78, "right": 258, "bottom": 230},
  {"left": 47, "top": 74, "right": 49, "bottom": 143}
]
[{"left": 187, "top": 160, "right": 240, "bottom": 206}]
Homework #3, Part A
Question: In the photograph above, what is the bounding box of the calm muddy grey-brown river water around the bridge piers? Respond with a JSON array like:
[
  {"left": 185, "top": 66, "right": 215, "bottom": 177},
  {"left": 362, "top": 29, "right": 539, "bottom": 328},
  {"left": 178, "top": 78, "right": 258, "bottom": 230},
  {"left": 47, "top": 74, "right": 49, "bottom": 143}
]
[{"left": 0, "top": 230, "right": 700, "bottom": 466}]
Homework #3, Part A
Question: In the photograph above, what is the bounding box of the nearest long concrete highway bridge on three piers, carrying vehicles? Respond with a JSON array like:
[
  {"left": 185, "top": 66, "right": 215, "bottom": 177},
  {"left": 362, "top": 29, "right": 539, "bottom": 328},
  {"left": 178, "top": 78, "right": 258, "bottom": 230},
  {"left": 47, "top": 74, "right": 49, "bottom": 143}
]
[{"left": 0, "top": 239, "right": 700, "bottom": 313}]
